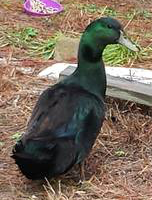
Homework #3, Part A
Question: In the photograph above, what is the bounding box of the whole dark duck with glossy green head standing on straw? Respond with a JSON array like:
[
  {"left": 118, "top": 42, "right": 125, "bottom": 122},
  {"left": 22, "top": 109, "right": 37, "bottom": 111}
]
[{"left": 11, "top": 17, "right": 139, "bottom": 181}]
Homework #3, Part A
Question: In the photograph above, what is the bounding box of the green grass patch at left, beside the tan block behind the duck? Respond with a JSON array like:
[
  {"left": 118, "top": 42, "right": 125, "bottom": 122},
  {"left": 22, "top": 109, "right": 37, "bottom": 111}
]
[{"left": 0, "top": 27, "right": 62, "bottom": 59}]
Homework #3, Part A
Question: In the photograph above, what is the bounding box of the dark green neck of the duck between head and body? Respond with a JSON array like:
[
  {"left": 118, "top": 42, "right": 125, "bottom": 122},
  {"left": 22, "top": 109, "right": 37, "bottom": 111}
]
[{"left": 73, "top": 38, "right": 106, "bottom": 98}]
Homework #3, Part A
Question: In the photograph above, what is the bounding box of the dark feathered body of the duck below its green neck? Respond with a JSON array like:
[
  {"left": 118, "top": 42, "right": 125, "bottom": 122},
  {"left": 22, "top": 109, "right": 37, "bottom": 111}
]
[{"left": 13, "top": 83, "right": 104, "bottom": 179}]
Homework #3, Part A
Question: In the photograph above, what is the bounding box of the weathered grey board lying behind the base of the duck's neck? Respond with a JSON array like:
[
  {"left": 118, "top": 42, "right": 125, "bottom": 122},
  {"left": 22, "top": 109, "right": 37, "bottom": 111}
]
[{"left": 60, "top": 65, "right": 152, "bottom": 106}]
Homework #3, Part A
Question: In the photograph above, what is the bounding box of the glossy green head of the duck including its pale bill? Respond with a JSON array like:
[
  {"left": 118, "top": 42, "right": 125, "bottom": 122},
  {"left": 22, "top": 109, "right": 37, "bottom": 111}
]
[{"left": 80, "top": 17, "right": 139, "bottom": 60}]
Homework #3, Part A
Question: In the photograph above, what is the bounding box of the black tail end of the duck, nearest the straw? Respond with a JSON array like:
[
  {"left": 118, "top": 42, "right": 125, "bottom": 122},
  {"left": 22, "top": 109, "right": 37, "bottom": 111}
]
[{"left": 11, "top": 140, "right": 76, "bottom": 180}]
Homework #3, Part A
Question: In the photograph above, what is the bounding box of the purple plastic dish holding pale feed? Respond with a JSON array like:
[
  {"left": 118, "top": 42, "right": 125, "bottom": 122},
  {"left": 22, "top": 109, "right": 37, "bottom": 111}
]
[{"left": 23, "top": 0, "right": 63, "bottom": 17}]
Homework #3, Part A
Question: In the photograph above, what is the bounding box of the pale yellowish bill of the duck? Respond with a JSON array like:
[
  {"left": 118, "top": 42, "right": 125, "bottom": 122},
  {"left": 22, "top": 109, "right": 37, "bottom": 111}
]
[{"left": 118, "top": 31, "right": 140, "bottom": 52}]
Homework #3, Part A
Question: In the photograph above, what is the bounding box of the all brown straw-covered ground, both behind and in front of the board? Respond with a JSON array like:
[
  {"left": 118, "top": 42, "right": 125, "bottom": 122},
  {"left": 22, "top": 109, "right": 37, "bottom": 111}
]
[{"left": 0, "top": 0, "right": 152, "bottom": 200}]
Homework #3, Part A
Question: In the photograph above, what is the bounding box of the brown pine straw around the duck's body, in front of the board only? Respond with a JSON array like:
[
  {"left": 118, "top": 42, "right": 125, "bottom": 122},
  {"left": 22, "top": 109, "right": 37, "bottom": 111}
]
[{"left": 0, "top": 64, "right": 152, "bottom": 200}]
